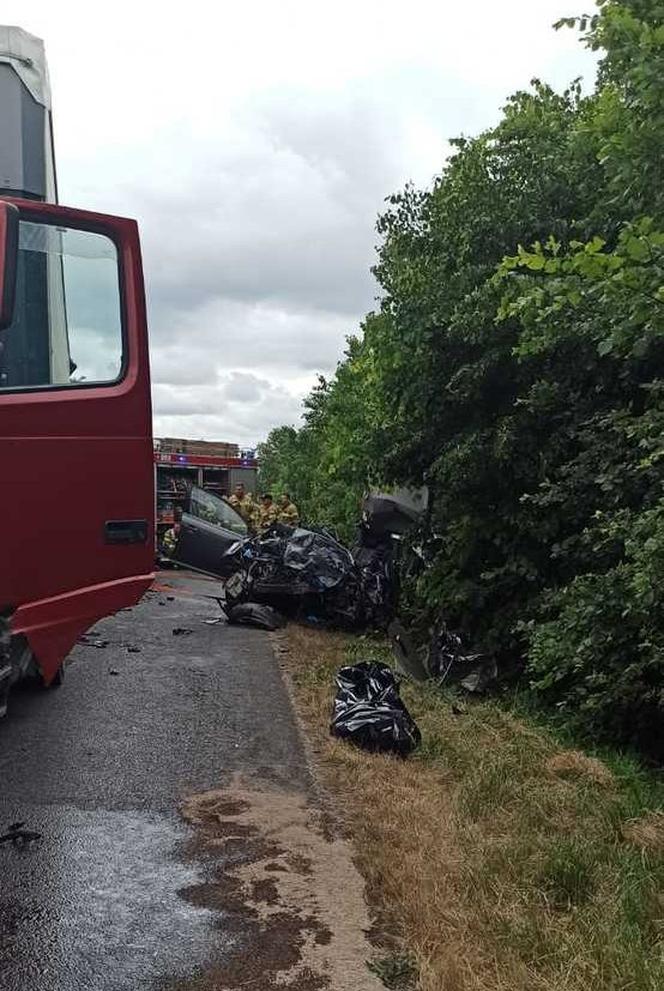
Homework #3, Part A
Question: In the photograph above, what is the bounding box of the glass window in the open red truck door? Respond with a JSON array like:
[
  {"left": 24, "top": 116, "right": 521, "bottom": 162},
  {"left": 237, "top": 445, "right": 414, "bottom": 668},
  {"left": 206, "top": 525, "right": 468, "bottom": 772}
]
[{"left": 0, "top": 220, "right": 124, "bottom": 389}]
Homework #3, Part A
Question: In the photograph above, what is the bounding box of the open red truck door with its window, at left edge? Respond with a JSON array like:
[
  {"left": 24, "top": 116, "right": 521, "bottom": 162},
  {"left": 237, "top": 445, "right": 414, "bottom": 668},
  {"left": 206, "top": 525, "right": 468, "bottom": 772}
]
[{"left": 0, "top": 200, "right": 154, "bottom": 683}]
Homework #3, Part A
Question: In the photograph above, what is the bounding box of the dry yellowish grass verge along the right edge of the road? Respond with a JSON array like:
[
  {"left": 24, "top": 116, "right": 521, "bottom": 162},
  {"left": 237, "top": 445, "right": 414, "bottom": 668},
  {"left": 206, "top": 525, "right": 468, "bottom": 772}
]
[{"left": 287, "top": 627, "right": 664, "bottom": 991}]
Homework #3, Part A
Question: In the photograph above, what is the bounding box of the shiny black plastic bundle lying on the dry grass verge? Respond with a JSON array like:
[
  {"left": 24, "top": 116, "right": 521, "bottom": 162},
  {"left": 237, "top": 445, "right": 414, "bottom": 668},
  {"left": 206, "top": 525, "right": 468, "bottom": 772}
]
[{"left": 330, "top": 661, "right": 421, "bottom": 757}]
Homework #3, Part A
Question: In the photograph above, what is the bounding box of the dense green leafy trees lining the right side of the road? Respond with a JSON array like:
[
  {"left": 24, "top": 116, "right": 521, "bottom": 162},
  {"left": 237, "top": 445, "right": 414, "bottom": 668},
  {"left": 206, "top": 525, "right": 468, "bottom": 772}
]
[{"left": 256, "top": 0, "right": 664, "bottom": 753}]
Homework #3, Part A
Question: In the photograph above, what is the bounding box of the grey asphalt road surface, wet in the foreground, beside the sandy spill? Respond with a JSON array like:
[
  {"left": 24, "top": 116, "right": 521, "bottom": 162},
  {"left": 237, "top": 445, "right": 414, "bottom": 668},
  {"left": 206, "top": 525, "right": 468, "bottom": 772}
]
[{"left": 0, "top": 575, "right": 319, "bottom": 991}]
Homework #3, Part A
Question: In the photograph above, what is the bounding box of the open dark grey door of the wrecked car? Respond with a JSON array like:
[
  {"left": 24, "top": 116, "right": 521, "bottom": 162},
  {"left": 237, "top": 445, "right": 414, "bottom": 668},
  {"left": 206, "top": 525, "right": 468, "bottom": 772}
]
[{"left": 172, "top": 485, "right": 248, "bottom": 576}]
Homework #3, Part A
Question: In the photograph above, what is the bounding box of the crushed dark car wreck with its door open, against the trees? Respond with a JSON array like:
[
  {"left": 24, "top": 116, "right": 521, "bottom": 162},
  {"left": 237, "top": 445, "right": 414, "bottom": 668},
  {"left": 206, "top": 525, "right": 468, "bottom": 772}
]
[{"left": 164, "top": 486, "right": 421, "bottom": 628}]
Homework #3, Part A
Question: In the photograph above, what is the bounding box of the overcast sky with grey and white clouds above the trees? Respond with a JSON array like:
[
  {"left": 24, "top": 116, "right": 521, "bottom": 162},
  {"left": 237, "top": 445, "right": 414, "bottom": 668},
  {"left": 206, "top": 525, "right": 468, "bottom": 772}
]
[{"left": 2, "top": 0, "right": 593, "bottom": 446}]
